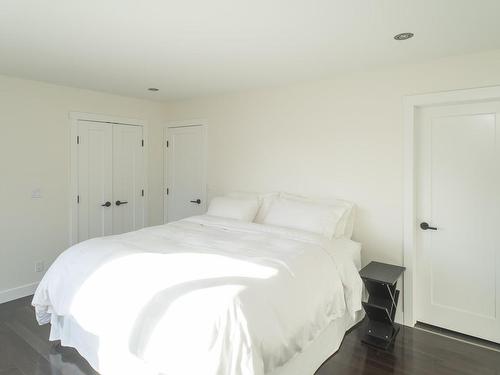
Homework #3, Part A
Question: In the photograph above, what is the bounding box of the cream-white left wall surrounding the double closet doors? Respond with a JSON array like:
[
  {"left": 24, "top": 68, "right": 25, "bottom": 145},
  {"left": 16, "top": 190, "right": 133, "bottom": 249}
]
[{"left": 0, "top": 76, "right": 165, "bottom": 302}]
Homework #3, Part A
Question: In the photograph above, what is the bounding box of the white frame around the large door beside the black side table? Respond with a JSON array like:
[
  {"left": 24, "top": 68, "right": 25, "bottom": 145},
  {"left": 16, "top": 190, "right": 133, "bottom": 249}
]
[{"left": 403, "top": 86, "right": 500, "bottom": 327}]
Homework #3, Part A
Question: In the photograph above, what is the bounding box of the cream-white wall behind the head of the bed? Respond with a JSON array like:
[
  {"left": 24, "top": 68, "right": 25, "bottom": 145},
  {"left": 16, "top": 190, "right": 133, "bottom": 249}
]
[{"left": 166, "top": 51, "right": 500, "bottom": 263}]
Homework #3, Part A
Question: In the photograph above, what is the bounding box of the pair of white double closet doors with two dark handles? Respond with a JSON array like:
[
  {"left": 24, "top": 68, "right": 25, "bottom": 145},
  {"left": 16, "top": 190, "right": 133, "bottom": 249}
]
[{"left": 76, "top": 120, "right": 145, "bottom": 242}]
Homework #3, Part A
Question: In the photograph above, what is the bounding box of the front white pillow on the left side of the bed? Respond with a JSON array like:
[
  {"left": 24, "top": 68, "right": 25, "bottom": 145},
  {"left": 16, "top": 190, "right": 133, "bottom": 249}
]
[{"left": 207, "top": 197, "right": 260, "bottom": 222}]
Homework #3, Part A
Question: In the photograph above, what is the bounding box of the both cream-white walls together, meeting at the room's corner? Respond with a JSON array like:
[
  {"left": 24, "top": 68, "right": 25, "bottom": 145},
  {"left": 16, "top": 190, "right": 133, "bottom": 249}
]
[{"left": 0, "top": 51, "right": 500, "bottom": 308}]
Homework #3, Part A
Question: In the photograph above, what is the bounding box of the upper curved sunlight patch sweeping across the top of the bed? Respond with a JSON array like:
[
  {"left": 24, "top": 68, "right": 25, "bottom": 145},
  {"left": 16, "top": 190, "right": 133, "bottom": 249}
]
[{"left": 70, "top": 253, "right": 278, "bottom": 345}]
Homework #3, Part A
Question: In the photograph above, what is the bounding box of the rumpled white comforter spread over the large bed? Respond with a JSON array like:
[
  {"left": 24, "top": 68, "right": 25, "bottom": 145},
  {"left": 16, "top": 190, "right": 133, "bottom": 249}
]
[{"left": 33, "top": 216, "right": 362, "bottom": 375}]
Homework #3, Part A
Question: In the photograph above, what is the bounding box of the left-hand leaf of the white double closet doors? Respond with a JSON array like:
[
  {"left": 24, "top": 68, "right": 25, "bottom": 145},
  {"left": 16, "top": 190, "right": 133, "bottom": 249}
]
[{"left": 77, "top": 121, "right": 113, "bottom": 242}]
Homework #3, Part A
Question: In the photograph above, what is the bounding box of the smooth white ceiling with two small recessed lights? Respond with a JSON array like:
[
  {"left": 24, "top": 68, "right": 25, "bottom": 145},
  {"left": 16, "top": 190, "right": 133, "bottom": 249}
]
[{"left": 0, "top": 0, "right": 500, "bottom": 100}]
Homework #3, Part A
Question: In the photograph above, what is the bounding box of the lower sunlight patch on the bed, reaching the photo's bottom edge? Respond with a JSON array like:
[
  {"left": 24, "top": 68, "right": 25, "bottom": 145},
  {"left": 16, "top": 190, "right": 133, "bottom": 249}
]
[{"left": 140, "top": 285, "right": 252, "bottom": 374}]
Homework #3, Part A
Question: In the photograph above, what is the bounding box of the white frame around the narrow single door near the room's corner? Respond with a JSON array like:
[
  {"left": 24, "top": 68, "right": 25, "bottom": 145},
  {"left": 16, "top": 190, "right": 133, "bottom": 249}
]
[{"left": 162, "top": 119, "right": 208, "bottom": 224}]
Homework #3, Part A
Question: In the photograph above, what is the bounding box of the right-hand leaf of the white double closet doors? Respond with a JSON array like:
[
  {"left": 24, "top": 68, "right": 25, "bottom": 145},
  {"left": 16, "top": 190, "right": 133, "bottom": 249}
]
[{"left": 113, "top": 124, "right": 144, "bottom": 234}]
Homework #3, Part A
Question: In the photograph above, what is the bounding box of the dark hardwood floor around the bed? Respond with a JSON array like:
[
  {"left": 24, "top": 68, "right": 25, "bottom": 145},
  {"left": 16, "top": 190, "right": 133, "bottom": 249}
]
[{"left": 0, "top": 298, "right": 500, "bottom": 375}]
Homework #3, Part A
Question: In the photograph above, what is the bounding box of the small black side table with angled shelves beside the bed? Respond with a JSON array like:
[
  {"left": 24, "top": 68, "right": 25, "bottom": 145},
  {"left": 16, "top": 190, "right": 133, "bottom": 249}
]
[{"left": 359, "top": 262, "right": 406, "bottom": 350}]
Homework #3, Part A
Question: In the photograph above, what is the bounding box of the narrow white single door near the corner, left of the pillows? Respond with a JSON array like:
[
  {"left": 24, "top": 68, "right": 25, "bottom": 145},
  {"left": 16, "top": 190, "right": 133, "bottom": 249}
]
[{"left": 165, "top": 125, "right": 206, "bottom": 221}]
